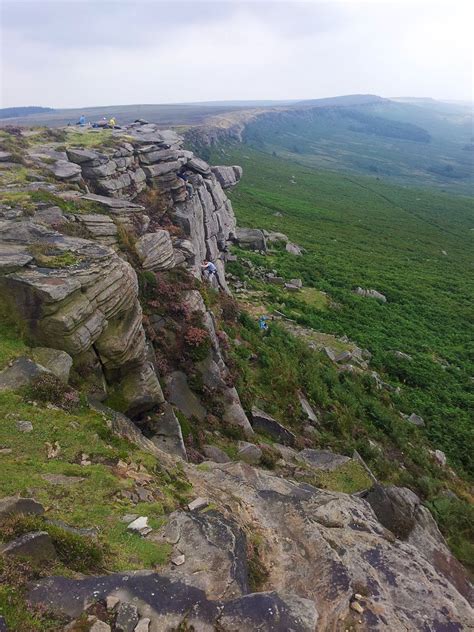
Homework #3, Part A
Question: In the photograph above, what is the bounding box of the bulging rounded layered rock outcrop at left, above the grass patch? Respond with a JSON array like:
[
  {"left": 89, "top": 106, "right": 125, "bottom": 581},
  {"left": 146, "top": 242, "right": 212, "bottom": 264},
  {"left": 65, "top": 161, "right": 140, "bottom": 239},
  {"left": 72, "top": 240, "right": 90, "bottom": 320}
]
[{"left": 0, "top": 219, "right": 163, "bottom": 414}]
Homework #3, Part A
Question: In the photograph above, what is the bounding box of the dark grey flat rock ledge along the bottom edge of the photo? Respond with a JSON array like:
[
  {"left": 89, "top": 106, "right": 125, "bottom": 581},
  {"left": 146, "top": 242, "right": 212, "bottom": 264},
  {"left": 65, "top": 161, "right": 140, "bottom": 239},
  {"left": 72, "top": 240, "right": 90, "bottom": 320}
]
[{"left": 29, "top": 571, "right": 318, "bottom": 632}]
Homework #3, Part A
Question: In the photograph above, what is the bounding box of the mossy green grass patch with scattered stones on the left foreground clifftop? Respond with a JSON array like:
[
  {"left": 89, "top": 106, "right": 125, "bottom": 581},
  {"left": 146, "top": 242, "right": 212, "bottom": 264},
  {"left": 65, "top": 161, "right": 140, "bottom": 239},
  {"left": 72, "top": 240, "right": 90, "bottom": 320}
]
[{"left": 0, "top": 392, "right": 183, "bottom": 570}]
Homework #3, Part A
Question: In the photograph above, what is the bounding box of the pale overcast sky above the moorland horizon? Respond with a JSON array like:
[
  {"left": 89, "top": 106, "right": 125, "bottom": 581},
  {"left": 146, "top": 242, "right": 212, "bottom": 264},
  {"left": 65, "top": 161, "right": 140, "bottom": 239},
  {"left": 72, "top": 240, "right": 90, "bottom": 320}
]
[{"left": 0, "top": 0, "right": 474, "bottom": 107}]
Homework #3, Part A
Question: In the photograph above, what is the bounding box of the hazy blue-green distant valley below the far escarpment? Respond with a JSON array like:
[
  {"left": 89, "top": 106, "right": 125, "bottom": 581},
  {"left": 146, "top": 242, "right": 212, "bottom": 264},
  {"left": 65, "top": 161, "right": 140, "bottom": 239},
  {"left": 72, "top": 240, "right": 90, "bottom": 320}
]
[{"left": 244, "top": 101, "right": 474, "bottom": 195}]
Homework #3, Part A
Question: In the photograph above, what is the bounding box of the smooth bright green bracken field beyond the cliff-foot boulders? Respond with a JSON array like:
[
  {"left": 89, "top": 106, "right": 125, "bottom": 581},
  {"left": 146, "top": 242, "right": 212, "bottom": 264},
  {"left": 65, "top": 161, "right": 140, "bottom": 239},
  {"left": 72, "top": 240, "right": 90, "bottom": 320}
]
[{"left": 214, "top": 147, "right": 473, "bottom": 472}]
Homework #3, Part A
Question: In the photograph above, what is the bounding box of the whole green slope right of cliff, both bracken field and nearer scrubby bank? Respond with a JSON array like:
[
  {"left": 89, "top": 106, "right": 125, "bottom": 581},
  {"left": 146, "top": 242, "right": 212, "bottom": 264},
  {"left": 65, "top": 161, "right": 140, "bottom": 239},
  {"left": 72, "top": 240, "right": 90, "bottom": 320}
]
[{"left": 212, "top": 146, "right": 474, "bottom": 567}]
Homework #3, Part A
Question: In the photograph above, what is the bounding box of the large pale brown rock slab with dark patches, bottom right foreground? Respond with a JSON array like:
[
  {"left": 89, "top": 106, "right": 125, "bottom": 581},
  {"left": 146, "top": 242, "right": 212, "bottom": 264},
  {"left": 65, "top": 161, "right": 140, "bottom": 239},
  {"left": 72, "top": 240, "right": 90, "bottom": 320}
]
[{"left": 186, "top": 463, "right": 473, "bottom": 632}]
